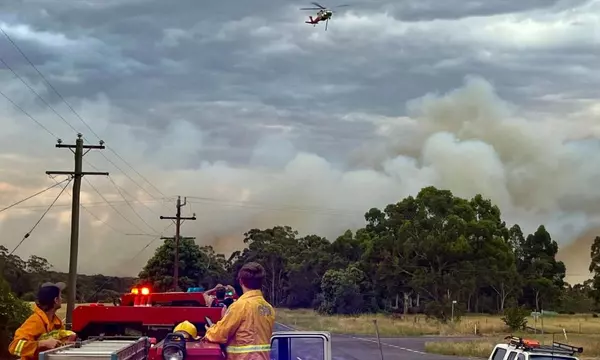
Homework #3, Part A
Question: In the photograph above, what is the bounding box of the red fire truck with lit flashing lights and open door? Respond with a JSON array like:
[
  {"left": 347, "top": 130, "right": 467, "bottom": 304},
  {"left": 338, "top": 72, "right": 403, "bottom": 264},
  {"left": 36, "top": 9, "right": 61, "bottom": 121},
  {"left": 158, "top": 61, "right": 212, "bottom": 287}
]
[{"left": 39, "top": 286, "right": 331, "bottom": 360}]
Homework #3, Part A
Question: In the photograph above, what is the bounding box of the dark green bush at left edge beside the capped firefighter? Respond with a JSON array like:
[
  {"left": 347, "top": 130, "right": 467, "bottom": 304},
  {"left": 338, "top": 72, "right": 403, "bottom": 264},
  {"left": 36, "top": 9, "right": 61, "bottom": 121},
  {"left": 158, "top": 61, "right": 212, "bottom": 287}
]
[{"left": 0, "top": 277, "right": 32, "bottom": 359}]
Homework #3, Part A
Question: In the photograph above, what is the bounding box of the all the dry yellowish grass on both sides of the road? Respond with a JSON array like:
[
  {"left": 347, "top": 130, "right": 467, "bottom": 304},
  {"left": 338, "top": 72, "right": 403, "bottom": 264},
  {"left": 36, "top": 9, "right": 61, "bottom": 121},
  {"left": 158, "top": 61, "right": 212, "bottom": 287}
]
[{"left": 277, "top": 309, "right": 600, "bottom": 359}]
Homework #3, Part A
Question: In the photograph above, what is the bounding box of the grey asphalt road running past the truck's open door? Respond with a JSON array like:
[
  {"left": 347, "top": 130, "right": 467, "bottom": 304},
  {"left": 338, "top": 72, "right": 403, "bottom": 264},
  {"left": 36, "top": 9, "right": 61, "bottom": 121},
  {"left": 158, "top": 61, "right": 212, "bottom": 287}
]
[{"left": 271, "top": 324, "right": 473, "bottom": 360}]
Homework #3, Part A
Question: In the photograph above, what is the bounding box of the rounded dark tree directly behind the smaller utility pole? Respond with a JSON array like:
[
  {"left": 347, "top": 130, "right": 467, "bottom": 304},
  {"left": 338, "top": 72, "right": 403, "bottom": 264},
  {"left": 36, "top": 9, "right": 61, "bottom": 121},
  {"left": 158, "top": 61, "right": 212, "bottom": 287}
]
[{"left": 139, "top": 239, "right": 209, "bottom": 291}]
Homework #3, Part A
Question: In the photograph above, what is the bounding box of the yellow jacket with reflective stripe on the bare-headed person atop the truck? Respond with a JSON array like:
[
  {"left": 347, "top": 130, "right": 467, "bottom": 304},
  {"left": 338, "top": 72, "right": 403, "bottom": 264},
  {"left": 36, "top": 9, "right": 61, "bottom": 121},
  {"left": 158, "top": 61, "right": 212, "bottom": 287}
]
[{"left": 205, "top": 290, "right": 275, "bottom": 360}]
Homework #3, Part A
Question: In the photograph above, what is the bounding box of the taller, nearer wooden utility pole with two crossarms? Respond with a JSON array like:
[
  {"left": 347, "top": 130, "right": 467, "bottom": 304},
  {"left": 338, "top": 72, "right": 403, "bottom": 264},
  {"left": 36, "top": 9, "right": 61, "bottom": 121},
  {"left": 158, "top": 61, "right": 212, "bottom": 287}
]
[{"left": 46, "top": 134, "right": 108, "bottom": 330}]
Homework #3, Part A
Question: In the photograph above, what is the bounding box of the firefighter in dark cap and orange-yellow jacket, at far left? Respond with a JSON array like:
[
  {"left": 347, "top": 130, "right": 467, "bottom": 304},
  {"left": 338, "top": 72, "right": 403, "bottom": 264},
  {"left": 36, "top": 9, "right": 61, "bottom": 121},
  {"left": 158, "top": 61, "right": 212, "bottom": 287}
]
[{"left": 8, "top": 282, "right": 76, "bottom": 360}]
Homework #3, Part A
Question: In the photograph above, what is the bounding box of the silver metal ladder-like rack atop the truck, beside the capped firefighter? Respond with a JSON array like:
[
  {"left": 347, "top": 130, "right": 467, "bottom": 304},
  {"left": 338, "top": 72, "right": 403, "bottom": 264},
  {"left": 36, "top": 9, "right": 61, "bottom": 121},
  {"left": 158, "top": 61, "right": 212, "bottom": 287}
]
[{"left": 38, "top": 337, "right": 150, "bottom": 360}]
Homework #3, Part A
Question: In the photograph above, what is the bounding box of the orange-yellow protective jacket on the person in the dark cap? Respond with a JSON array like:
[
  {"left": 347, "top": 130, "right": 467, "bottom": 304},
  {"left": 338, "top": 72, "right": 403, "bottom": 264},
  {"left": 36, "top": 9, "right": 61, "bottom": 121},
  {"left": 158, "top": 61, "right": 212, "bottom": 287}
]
[{"left": 8, "top": 305, "right": 65, "bottom": 360}]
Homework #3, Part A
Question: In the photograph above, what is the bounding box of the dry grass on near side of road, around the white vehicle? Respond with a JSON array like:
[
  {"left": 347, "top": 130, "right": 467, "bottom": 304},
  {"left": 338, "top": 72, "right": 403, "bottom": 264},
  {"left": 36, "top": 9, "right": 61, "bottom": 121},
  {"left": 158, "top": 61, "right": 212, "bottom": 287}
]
[{"left": 425, "top": 334, "right": 600, "bottom": 359}]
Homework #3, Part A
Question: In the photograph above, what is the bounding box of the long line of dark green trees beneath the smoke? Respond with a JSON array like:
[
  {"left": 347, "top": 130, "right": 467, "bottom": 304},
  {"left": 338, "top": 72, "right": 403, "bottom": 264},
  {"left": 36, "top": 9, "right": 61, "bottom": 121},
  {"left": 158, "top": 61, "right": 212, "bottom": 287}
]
[{"left": 139, "top": 187, "right": 600, "bottom": 321}]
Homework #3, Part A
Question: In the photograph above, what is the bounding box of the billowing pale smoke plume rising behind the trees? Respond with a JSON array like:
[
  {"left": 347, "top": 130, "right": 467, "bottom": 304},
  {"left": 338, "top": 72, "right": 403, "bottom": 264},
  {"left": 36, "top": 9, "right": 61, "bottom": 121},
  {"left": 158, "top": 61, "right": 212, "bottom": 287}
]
[{"left": 0, "top": 78, "right": 600, "bottom": 281}]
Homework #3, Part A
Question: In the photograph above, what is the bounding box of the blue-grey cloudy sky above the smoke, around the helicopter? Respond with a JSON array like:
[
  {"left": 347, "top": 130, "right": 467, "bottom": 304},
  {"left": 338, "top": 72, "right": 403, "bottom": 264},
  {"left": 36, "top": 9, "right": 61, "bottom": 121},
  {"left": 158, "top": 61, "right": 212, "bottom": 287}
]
[{"left": 0, "top": 0, "right": 597, "bottom": 166}]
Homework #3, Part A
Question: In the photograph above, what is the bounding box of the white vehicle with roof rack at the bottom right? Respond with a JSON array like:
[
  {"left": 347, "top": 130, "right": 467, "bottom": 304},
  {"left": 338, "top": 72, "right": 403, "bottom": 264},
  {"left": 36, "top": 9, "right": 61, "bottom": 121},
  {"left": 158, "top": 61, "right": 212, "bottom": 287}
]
[{"left": 489, "top": 336, "right": 583, "bottom": 360}]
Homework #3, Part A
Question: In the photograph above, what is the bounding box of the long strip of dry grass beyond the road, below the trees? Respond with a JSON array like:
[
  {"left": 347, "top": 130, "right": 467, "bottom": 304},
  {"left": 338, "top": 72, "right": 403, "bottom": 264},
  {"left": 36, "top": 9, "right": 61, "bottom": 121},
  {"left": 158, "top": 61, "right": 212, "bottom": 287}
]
[{"left": 277, "top": 309, "right": 600, "bottom": 336}]
